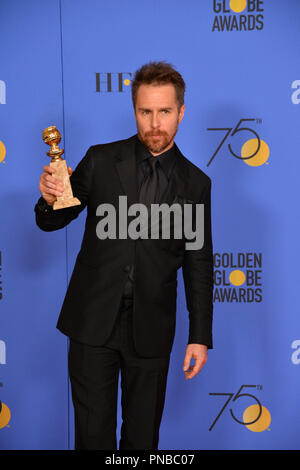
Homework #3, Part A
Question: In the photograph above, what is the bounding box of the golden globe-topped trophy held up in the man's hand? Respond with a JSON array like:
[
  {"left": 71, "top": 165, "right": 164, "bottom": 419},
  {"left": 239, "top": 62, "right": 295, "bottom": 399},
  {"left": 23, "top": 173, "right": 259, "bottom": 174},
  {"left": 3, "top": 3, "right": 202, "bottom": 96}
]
[{"left": 43, "top": 126, "right": 81, "bottom": 210}]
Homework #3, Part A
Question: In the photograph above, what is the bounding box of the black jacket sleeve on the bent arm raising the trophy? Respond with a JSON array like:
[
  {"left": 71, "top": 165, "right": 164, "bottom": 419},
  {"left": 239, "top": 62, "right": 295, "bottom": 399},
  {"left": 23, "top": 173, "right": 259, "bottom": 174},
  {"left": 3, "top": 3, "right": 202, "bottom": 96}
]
[{"left": 34, "top": 147, "right": 94, "bottom": 232}]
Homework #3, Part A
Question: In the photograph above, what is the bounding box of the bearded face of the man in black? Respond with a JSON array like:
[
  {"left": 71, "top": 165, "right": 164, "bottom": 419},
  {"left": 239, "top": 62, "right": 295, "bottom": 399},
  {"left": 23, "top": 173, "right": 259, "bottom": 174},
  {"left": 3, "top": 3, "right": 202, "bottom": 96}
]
[{"left": 135, "top": 84, "right": 185, "bottom": 156}]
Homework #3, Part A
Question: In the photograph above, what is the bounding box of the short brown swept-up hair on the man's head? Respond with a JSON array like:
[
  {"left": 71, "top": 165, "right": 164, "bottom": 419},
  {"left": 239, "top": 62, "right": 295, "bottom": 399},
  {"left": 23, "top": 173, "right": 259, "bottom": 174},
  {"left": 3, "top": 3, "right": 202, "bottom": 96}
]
[{"left": 131, "top": 61, "right": 185, "bottom": 108}]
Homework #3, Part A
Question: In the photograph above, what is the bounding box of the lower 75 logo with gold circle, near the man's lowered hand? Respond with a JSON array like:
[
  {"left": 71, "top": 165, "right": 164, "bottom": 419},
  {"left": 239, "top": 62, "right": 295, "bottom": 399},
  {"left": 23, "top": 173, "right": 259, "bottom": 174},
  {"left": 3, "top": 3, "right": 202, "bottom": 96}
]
[{"left": 209, "top": 385, "right": 271, "bottom": 432}]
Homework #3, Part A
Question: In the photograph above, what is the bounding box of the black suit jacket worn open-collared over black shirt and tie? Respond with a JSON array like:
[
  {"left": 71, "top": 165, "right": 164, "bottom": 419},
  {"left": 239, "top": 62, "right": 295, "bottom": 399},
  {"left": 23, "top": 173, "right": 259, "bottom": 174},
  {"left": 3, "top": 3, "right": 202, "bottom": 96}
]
[{"left": 35, "top": 135, "right": 213, "bottom": 357}]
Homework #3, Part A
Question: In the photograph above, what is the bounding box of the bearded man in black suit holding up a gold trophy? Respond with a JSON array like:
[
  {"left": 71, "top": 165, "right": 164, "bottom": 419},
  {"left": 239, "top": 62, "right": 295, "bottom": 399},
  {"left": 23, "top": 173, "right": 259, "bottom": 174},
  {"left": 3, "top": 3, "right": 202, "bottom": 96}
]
[{"left": 35, "top": 62, "right": 213, "bottom": 449}]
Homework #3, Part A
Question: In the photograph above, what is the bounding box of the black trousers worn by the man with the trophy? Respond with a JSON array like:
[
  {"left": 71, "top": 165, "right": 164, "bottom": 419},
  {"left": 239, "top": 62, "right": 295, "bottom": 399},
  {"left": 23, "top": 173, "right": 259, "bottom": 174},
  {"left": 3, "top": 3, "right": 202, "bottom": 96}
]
[{"left": 69, "top": 299, "right": 170, "bottom": 450}]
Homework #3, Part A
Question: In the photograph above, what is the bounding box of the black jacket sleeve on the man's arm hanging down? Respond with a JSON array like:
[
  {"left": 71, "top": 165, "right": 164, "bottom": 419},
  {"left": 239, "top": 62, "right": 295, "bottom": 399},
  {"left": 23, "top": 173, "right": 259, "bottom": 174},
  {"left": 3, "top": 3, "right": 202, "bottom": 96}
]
[{"left": 182, "top": 178, "right": 213, "bottom": 349}]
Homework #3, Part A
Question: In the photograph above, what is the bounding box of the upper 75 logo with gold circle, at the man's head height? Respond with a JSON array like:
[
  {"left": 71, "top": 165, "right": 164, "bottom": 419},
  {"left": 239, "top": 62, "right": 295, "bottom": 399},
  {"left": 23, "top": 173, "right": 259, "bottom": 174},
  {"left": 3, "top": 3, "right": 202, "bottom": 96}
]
[{"left": 206, "top": 118, "right": 270, "bottom": 166}]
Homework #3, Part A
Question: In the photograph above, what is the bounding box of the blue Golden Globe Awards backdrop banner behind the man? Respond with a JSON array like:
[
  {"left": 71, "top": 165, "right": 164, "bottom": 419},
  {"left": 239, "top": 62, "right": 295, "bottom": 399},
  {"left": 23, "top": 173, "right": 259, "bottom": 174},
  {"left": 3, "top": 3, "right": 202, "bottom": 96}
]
[{"left": 0, "top": 0, "right": 300, "bottom": 449}]
